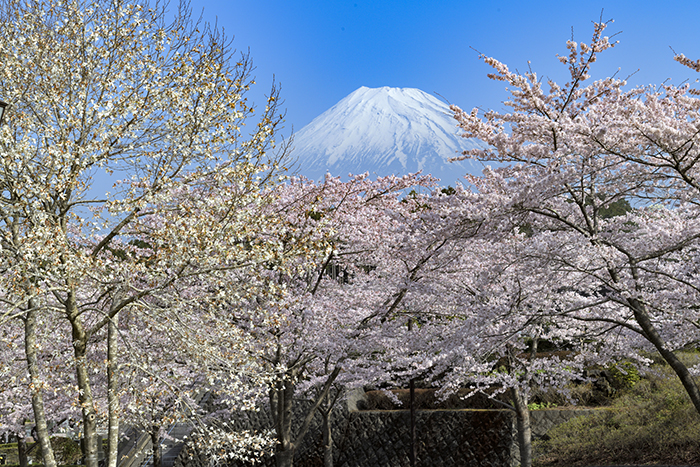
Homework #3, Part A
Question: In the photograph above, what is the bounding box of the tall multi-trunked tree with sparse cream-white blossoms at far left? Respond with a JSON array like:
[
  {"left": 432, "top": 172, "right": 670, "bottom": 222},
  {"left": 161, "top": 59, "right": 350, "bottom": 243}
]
[{"left": 0, "top": 0, "right": 290, "bottom": 467}]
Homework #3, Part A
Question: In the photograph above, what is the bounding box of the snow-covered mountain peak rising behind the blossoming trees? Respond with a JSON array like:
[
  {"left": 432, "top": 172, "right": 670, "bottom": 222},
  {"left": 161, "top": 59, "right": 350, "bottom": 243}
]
[{"left": 292, "top": 86, "right": 485, "bottom": 186}]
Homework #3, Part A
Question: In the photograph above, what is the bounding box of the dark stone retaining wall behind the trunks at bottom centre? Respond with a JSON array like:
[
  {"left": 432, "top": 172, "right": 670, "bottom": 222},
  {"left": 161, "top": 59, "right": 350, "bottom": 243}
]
[{"left": 175, "top": 399, "right": 595, "bottom": 467}]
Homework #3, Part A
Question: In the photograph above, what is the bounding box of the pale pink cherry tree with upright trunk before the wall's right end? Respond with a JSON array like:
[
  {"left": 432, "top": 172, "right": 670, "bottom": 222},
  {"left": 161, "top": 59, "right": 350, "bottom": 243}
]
[{"left": 409, "top": 218, "right": 646, "bottom": 466}]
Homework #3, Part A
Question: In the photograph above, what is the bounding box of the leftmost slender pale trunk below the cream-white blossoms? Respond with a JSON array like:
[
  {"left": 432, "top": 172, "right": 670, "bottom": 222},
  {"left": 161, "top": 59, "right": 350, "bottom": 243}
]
[{"left": 22, "top": 299, "right": 56, "bottom": 467}]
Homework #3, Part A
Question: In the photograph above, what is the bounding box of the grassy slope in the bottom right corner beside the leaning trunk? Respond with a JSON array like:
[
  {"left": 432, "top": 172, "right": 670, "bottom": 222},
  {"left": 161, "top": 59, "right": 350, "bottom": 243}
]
[{"left": 534, "top": 355, "right": 700, "bottom": 467}]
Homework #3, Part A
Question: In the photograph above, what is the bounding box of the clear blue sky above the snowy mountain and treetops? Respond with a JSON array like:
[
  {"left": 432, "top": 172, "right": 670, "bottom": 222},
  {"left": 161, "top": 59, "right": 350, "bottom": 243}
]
[{"left": 191, "top": 0, "right": 700, "bottom": 139}]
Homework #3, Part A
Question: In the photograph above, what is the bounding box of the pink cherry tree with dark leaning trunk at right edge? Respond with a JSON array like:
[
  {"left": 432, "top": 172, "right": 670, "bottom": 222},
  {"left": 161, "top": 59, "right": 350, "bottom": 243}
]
[{"left": 453, "top": 22, "right": 700, "bottom": 442}]
